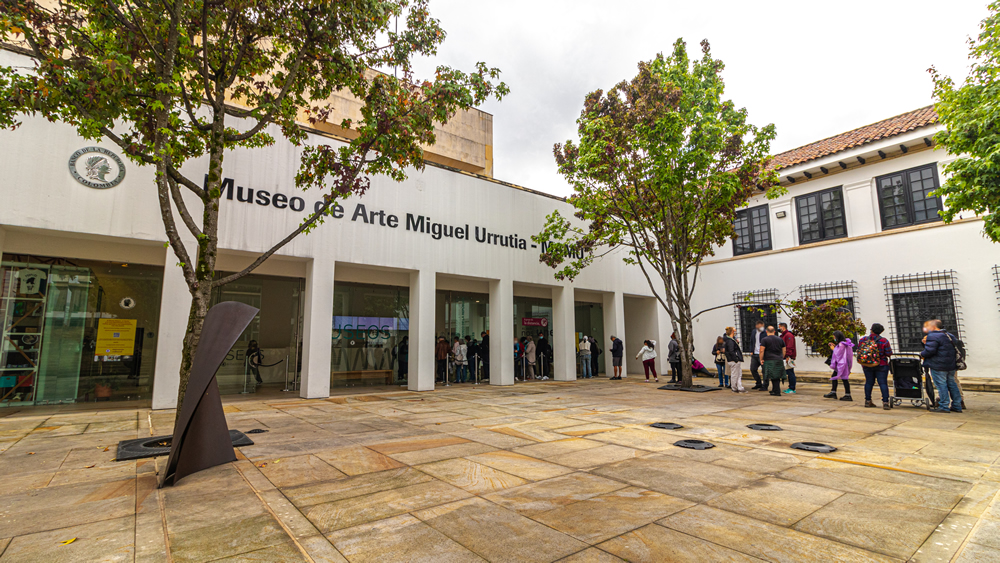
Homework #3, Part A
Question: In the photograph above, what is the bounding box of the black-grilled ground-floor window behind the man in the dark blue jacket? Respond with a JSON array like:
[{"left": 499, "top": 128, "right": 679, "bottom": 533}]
[{"left": 884, "top": 270, "right": 962, "bottom": 354}]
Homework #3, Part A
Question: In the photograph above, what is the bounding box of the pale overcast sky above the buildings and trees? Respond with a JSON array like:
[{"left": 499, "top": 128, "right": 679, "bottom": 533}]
[{"left": 412, "top": 0, "right": 986, "bottom": 195}]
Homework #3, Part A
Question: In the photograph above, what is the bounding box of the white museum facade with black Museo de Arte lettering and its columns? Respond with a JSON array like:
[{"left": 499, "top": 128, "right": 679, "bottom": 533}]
[{"left": 0, "top": 110, "right": 669, "bottom": 408}]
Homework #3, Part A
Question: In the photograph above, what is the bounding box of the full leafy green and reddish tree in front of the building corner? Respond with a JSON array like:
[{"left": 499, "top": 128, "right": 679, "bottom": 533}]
[{"left": 532, "top": 39, "right": 780, "bottom": 387}]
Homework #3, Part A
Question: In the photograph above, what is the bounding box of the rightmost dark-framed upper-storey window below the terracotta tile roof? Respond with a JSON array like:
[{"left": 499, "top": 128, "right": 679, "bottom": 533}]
[{"left": 875, "top": 163, "right": 942, "bottom": 229}]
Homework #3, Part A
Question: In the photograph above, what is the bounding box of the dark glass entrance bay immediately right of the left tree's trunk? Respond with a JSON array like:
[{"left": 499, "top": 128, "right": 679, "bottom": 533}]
[{"left": 212, "top": 272, "right": 305, "bottom": 395}]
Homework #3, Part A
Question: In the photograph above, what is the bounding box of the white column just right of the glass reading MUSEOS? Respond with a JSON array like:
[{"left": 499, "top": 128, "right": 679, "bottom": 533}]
[{"left": 407, "top": 270, "right": 437, "bottom": 391}]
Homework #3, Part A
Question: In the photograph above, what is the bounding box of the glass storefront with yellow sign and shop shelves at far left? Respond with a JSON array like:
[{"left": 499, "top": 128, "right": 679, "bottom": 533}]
[{"left": 0, "top": 254, "right": 163, "bottom": 406}]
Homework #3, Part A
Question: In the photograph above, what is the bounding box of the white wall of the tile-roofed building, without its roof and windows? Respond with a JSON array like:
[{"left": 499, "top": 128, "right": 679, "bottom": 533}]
[{"left": 693, "top": 125, "right": 1000, "bottom": 377}]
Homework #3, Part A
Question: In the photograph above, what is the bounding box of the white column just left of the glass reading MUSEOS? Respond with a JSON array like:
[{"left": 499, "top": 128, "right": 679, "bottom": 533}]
[{"left": 299, "top": 256, "right": 336, "bottom": 399}]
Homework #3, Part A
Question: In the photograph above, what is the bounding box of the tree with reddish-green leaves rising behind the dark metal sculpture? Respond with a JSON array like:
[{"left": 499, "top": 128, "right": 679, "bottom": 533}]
[{"left": 0, "top": 0, "right": 507, "bottom": 413}]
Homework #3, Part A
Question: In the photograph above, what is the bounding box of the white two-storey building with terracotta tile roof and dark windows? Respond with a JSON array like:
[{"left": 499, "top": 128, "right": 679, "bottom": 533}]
[{"left": 694, "top": 107, "right": 1000, "bottom": 377}]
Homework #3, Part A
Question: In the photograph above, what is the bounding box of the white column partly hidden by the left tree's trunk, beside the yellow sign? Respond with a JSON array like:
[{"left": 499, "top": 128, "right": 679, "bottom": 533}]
[{"left": 153, "top": 256, "right": 191, "bottom": 409}]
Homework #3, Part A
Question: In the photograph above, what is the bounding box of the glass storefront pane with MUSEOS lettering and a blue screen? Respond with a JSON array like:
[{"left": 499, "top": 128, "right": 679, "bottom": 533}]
[{"left": 330, "top": 282, "right": 410, "bottom": 387}]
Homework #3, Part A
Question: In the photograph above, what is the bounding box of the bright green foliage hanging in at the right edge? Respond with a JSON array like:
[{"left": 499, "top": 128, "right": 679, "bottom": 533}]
[{"left": 930, "top": 2, "right": 1000, "bottom": 242}]
